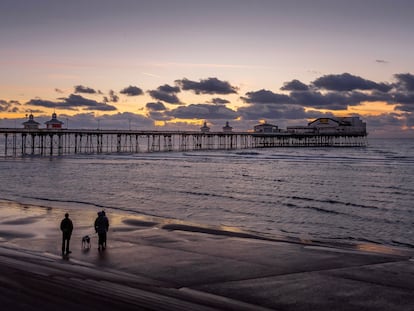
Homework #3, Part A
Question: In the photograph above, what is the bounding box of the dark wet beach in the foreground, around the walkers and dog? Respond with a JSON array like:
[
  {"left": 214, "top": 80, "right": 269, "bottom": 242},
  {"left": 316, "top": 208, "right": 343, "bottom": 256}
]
[{"left": 0, "top": 202, "right": 414, "bottom": 310}]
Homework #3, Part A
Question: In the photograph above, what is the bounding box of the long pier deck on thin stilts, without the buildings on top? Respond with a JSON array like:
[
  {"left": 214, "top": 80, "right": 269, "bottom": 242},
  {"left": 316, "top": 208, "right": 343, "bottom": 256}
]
[{"left": 0, "top": 128, "right": 367, "bottom": 157}]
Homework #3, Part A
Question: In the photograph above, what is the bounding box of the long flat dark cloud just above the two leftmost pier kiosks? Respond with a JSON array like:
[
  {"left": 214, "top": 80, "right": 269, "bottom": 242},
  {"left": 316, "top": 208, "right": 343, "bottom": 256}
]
[{"left": 26, "top": 94, "right": 117, "bottom": 111}]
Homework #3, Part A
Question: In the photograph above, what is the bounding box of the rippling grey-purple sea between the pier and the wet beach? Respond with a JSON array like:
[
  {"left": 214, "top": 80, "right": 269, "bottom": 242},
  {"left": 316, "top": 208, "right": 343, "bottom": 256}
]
[{"left": 0, "top": 139, "right": 414, "bottom": 249}]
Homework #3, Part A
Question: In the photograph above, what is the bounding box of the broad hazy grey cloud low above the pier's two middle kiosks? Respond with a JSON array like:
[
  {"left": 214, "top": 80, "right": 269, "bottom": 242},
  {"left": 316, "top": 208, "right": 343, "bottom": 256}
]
[{"left": 166, "top": 104, "right": 238, "bottom": 120}]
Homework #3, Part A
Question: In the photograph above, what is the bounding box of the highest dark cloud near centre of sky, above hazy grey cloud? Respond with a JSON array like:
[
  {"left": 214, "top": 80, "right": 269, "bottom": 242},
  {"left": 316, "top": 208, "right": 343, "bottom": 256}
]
[{"left": 175, "top": 78, "right": 237, "bottom": 94}]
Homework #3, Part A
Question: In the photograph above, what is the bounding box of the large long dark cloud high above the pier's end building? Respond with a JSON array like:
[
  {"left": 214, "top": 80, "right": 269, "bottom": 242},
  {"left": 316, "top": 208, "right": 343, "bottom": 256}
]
[{"left": 312, "top": 73, "right": 392, "bottom": 92}]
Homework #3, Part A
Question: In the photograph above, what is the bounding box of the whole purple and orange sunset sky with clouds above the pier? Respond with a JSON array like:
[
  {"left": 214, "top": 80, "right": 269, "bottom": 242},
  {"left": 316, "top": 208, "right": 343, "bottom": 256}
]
[{"left": 0, "top": 0, "right": 414, "bottom": 138}]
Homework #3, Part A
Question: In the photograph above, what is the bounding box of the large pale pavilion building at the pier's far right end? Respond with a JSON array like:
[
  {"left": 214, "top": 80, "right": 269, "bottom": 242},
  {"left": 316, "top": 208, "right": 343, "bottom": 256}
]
[{"left": 287, "top": 117, "right": 367, "bottom": 134}]
